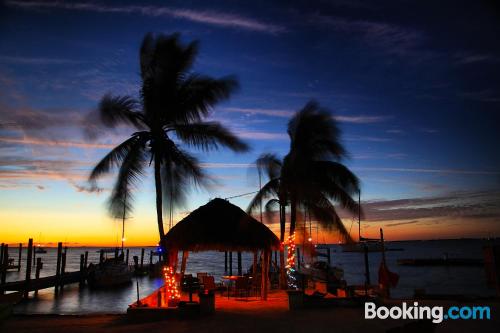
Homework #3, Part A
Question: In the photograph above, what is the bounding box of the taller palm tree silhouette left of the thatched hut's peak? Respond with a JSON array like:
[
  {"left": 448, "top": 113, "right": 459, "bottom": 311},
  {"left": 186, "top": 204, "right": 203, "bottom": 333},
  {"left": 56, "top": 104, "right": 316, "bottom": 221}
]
[{"left": 89, "top": 34, "right": 248, "bottom": 254}]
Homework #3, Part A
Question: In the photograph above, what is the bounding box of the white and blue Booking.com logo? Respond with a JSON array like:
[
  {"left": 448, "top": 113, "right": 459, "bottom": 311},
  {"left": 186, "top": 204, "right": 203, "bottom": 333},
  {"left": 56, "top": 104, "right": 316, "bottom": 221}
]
[{"left": 365, "top": 302, "right": 490, "bottom": 324}]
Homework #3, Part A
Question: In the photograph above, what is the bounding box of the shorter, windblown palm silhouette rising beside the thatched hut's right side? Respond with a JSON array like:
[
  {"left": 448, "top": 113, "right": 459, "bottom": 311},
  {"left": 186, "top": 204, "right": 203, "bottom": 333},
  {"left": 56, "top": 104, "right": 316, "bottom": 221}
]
[{"left": 248, "top": 102, "right": 359, "bottom": 248}]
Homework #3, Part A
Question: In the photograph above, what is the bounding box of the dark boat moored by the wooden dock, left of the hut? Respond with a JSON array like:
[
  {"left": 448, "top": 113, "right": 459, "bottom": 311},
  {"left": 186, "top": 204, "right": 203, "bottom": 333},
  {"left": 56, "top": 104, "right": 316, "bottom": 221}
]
[{"left": 87, "top": 255, "right": 132, "bottom": 288}]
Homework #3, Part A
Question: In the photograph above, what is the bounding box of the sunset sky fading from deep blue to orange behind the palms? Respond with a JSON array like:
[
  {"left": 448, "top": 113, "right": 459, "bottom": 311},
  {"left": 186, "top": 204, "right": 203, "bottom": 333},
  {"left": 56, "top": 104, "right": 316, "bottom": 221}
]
[{"left": 0, "top": 0, "right": 500, "bottom": 245}]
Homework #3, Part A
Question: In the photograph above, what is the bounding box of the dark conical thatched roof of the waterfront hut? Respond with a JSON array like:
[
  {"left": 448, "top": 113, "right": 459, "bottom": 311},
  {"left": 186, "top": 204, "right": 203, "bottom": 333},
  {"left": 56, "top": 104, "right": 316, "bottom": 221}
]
[{"left": 164, "top": 199, "right": 280, "bottom": 251}]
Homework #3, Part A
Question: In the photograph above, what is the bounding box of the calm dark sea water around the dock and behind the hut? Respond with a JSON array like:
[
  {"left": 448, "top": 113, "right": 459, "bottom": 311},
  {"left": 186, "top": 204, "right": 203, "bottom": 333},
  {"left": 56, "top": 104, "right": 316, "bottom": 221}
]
[{"left": 2, "top": 240, "right": 494, "bottom": 314}]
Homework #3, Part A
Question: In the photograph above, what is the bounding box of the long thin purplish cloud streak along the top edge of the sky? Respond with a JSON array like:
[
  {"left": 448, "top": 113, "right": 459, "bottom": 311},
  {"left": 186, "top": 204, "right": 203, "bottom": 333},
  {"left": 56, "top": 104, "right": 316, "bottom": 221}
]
[{"left": 5, "top": 1, "right": 286, "bottom": 34}]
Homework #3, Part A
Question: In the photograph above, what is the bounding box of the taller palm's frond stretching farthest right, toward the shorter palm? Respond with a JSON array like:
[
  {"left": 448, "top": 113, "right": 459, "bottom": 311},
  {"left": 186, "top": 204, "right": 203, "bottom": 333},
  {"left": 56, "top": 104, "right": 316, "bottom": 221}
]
[{"left": 173, "top": 122, "right": 249, "bottom": 152}]
